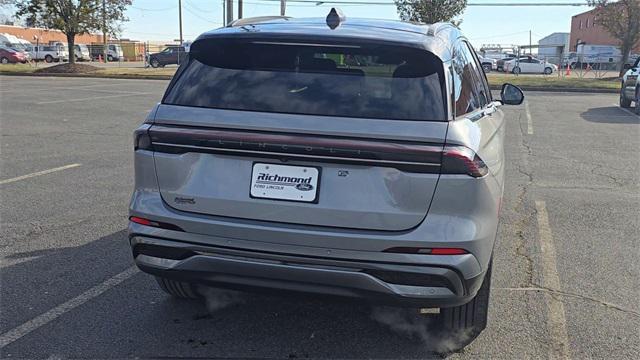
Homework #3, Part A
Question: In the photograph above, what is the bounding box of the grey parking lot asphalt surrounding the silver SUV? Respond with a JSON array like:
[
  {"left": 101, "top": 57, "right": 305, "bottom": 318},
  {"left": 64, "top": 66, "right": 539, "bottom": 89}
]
[{"left": 0, "top": 76, "right": 640, "bottom": 359}]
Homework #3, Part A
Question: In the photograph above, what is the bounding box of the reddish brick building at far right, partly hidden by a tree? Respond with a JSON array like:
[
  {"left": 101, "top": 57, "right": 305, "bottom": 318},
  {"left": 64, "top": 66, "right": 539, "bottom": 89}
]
[{"left": 569, "top": 9, "right": 640, "bottom": 53}]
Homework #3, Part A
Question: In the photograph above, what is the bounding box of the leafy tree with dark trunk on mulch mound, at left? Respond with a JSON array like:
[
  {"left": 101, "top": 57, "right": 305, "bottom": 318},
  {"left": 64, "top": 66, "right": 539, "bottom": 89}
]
[{"left": 16, "top": 0, "right": 131, "bottom": 63}]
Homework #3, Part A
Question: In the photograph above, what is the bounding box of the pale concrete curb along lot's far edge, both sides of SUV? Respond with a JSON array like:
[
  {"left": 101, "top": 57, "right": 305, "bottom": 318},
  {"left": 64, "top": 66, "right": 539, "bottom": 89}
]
[{"left": 0, "top": 72, "right": 619, "bottom": 94}]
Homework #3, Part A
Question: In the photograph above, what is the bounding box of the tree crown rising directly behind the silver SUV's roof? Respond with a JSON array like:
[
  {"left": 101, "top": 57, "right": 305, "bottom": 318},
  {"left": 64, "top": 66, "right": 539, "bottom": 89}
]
[{"left": 394, "top": 0, "right": 467, "bottom": 26}]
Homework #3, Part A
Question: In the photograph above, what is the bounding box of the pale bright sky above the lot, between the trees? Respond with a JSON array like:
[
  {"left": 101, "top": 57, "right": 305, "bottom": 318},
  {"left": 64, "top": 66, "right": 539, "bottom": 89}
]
[{"left": 122, "top": 0, "right": 589, "bottom": 48}]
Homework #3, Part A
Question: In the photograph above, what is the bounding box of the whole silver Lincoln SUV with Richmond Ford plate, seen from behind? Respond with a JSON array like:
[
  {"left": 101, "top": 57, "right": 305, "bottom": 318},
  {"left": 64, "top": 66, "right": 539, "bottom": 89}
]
[{"left": 129, "top": 10, "right": 524, "bottom": 345}]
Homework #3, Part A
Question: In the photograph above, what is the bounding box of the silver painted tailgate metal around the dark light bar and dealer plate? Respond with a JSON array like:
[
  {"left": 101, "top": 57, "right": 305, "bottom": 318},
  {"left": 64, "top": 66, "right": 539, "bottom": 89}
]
[{"left": 150, "top": 105, "right": 447, "bottom": 230}]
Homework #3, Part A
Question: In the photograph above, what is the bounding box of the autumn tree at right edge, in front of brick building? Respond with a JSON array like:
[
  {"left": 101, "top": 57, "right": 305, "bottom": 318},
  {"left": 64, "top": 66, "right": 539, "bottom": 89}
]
[{"left": 589, "top": 0, "right": 640, "bottom": 76}]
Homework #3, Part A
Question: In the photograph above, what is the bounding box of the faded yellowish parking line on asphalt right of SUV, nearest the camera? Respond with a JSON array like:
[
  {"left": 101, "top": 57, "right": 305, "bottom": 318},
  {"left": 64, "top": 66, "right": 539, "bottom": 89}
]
[{"left": 536, "top": 201, "right": 569, "bottom": 359}]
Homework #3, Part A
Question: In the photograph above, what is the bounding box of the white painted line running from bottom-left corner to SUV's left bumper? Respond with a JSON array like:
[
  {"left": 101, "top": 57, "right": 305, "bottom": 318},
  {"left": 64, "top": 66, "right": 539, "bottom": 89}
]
[{"left": 0, "top": 266, "right": 139, "bottom": 349}]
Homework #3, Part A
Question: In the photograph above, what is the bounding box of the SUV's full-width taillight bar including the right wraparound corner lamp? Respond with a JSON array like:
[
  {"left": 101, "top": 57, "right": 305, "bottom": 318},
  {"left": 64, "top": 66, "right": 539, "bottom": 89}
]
[{"left": 140, "top": 125, "right": 488, "bottom": 177}]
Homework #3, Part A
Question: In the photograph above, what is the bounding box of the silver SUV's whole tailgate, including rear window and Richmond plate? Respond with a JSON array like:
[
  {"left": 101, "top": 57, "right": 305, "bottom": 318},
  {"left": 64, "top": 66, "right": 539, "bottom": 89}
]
[{"left": 150, "top": 38, "right": 447, "bottom": 231}]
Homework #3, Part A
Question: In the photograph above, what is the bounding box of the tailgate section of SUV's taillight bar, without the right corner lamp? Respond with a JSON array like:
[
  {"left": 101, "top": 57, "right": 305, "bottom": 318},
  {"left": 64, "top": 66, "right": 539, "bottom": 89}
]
[{"left": 149, "top": 125, "right": 442, "bottom": 173}]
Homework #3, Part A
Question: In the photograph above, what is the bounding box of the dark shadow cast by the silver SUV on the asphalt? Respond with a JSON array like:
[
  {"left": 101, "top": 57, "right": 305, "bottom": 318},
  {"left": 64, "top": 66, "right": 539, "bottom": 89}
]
[{"left": 0, "top": 230, "right": 460, "bottom": 359}]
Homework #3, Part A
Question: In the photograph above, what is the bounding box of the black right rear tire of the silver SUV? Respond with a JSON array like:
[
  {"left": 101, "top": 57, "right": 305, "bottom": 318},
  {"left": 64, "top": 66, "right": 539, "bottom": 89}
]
[{"left": 438, "top": 261, "right": 493, "bottom": 349}]
